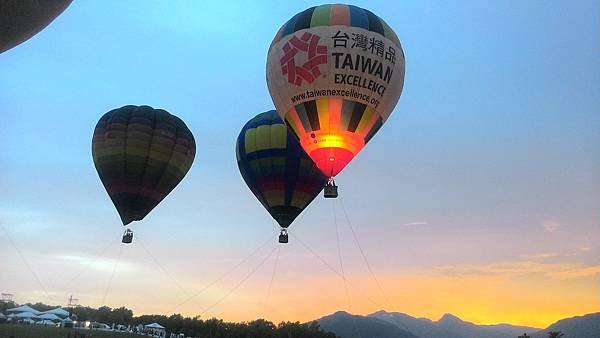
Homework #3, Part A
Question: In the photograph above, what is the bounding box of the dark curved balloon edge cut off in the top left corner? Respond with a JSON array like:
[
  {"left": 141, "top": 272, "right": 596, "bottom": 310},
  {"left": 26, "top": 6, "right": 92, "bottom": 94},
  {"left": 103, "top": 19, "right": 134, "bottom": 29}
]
[{"left": 0, "top": 0, "right": 72, "bottom": 53}]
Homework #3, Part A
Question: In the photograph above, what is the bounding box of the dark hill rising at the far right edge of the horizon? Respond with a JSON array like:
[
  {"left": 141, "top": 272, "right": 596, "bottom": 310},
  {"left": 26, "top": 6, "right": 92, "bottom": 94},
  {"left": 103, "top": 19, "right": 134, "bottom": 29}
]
[{"left": 531, "top": 312, "right": 600, "bottom": 338}]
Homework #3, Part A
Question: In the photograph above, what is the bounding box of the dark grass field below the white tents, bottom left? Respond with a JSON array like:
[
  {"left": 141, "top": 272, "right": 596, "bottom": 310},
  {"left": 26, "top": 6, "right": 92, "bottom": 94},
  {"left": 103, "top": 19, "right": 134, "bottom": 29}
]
[{"left": 0, "top": 324, "right": 144, "bottom": 338}]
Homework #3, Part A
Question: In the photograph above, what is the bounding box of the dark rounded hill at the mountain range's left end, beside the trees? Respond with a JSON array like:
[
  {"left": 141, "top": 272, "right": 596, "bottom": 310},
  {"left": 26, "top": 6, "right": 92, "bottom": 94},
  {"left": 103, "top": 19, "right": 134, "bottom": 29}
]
[{"left": 317, "top": 311, "right": 419, "bottom": 338}]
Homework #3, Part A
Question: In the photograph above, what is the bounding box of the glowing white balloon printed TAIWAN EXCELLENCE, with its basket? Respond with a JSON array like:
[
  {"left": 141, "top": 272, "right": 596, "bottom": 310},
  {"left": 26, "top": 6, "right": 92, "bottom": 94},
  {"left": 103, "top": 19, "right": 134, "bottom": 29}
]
[{"left": 267, "top": 4, "right": 404, "bottom": 197}]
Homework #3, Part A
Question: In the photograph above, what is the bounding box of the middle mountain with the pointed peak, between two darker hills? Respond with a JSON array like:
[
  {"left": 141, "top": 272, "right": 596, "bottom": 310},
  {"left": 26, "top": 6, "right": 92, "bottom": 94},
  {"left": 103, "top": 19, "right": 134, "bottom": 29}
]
[{"left": 369, "top": 311, "right": 540, "bottom": 338}]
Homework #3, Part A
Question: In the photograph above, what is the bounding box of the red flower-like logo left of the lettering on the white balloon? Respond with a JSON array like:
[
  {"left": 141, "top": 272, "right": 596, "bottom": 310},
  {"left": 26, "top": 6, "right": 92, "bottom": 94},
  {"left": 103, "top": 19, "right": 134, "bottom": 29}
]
[{"left": 279, "top": 32, "right": 327, "bottom": 86}]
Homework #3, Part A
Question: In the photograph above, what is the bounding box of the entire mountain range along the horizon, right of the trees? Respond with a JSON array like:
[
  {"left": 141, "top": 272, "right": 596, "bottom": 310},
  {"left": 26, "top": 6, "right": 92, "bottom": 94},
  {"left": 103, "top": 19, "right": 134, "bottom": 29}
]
[{"left": 317, "top": 311, "right": 600, "bottom": 338}]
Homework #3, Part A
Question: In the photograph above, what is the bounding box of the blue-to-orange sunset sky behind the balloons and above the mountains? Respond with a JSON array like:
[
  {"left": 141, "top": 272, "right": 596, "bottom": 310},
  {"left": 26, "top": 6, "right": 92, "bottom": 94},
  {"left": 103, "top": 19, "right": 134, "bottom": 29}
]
[{"left": 0, "top": 0, "right": 600, "bottom": 327}]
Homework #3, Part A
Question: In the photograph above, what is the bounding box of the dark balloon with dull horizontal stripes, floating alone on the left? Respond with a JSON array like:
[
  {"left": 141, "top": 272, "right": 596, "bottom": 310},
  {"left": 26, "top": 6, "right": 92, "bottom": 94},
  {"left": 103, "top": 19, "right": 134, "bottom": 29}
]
[{"left": 92, "top": 106, "right": 196, "bottom": 243}]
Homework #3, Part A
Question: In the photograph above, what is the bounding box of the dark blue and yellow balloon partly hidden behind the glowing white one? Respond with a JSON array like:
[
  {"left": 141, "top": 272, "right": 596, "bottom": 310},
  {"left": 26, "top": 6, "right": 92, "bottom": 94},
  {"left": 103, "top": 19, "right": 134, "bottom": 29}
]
[{"left": 235, "top": 110, "right": 327, "bottom": 243}]
